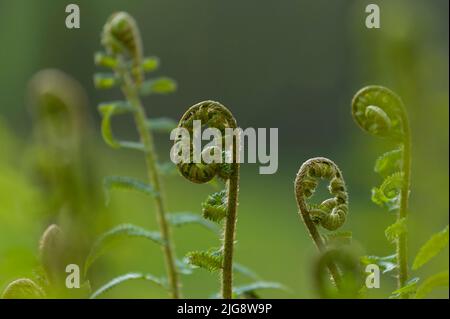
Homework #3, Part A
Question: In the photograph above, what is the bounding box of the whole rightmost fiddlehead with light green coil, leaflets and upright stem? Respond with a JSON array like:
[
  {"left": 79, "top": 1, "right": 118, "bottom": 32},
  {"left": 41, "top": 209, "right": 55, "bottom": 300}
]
[{"left": 352, "top": 85, "right": 411, "bottom": 297}]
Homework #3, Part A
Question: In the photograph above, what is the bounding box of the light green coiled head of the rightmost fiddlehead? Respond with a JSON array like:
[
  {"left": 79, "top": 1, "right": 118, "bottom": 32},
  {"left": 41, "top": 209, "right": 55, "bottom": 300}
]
[{"left": 352, "top": 85, "right": 406, "bottom": 138}]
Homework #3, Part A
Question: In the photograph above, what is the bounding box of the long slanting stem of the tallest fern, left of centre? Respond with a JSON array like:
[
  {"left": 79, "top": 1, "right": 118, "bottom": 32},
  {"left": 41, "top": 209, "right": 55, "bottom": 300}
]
[{"left": 122, "top": 60, "right": 181, "bottom": 299}]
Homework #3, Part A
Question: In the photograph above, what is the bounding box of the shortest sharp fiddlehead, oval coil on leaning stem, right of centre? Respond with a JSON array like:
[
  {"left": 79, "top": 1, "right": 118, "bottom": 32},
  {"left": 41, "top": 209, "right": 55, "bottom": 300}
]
[{"left": 294, "top": 157, "right": 348, "bottom": 288}]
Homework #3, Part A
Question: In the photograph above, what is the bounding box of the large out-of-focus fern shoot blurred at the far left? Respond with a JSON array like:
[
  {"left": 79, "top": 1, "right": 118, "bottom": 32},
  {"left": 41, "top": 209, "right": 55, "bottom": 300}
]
[{"left": 27, "top": 69, "right": 98, "bottom": 264}]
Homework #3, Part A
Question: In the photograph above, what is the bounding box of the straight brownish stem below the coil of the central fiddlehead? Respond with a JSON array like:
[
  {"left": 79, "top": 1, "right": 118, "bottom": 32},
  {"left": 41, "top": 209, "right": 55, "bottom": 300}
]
[{"left": 222, "top": 165, "right": 239, "bottom": 299}]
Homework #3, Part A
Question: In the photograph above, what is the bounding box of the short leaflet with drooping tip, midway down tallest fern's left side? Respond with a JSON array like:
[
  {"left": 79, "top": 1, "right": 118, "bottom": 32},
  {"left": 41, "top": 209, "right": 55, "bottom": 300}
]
[{"left": 103, "top": 176, "right": 158, "bottom": 205}]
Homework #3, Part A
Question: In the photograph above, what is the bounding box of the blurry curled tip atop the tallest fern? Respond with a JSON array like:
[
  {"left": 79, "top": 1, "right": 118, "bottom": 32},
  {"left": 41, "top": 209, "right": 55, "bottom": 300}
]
[{"left": 101, "top": 11, "right": 143, "bottom": 83}]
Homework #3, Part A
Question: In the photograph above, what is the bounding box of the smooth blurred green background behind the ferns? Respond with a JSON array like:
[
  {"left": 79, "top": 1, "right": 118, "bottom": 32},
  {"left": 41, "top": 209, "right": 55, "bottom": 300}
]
[{"left": 0, "top": 0, "right": 449, "bottom": 298}]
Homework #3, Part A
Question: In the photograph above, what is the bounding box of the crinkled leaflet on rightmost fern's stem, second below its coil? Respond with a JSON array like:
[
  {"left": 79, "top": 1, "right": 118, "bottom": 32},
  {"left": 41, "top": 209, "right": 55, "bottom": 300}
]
[{"left": 372, "top": 172, "right": 403, "bottom": 211}]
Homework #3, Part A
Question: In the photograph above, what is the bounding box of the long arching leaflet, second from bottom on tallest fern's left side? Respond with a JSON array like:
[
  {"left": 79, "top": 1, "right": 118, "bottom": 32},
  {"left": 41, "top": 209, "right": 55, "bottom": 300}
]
[{"left": 84, "top": 224, "right": 166, "bottom": 274}]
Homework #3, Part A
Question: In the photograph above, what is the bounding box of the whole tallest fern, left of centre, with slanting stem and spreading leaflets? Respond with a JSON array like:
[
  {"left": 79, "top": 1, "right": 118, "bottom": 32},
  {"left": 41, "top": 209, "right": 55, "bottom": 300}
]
[{"left": 92, "top": 12, "right": 181, "bottom": 298}]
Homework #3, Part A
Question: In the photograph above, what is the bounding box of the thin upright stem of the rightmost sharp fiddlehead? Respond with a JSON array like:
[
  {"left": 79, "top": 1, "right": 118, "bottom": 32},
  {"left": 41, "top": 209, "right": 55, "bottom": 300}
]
[{"left": 397, "top": 112, "right": 411, "bottom": 299}]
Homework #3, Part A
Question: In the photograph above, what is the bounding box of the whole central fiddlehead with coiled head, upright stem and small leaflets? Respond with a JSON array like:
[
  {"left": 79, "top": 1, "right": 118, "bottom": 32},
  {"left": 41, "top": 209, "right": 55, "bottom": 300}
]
[{"left": 175, "top": 101, "right": 239, "bottom": 299}]
